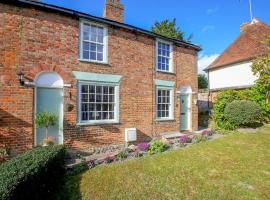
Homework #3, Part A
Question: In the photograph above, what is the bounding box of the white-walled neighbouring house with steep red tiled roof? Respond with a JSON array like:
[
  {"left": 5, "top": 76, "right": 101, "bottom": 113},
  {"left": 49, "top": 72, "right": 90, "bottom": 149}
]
[{"left": 205, "top": 18, "right": 270, "bottom": 104}]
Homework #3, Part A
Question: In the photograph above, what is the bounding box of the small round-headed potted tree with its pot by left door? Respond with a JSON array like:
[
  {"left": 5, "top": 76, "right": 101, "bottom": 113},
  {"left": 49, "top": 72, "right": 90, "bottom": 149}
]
[{"left": 35, "top": 111, "right": 58, "bottom": 146}]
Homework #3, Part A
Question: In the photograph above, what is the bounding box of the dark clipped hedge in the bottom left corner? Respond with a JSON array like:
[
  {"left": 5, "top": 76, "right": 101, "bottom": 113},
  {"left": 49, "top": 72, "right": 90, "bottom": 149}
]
[{"left": 0, "top": 145, "right": 65, "bottom": 200}]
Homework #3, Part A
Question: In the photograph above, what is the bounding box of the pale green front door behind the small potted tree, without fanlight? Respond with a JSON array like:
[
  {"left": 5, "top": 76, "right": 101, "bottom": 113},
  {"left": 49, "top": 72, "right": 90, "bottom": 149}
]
[{"left": 36, "top": 87, "right": 63, "bottom": 145}]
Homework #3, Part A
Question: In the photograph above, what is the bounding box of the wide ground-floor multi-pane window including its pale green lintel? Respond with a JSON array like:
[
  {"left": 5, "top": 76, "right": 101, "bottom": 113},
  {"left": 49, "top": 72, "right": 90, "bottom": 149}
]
[{"left": 73, "top": 72, "right": 121, "bottom": 125}]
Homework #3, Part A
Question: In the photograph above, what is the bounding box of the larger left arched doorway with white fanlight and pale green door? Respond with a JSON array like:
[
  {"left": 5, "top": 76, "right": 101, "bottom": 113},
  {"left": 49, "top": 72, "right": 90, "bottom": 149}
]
[{"left": 35, "top": 72, "right": 64, "bottom": 145}]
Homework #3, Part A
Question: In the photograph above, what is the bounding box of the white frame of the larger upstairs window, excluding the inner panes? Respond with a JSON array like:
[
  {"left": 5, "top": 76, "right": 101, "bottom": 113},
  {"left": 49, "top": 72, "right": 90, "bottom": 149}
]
[{"left": 79, "top": 19, "right": 108, "bottom": 64}]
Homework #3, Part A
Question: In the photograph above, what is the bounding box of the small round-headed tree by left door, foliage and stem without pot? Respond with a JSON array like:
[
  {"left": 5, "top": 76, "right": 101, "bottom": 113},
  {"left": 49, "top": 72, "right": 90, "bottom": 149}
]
[{"left": 35, "top": 111, "right": 58, "bottom": 139}]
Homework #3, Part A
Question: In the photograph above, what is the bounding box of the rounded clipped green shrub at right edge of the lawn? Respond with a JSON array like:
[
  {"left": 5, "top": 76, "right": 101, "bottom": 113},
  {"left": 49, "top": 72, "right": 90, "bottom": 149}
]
[{"left": 224, "top": 100, "right": 261, "bottom": 127}]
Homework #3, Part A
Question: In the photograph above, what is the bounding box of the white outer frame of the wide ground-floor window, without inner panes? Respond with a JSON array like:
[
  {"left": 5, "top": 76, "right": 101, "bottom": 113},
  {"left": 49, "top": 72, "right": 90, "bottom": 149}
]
[{"left": 77, "top": 81, "right": 119, "bottom": 125}]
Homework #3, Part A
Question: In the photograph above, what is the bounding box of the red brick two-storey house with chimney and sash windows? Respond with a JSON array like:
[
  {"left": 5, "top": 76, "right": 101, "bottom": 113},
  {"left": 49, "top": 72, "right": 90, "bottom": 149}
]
[{"left": 0, "top": 0, "right": 200, "bottom": 152}]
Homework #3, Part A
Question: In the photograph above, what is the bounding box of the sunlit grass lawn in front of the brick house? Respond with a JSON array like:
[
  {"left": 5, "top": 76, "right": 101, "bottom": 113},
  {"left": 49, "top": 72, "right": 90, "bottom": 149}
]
[{"left": 61, "top": 126, "right": 270, "bottom": 200}]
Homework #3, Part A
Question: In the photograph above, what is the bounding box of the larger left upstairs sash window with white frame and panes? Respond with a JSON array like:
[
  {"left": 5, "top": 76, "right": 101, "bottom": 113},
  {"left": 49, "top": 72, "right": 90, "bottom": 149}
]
[{"left": 80, "top": 22, "right": 107, "bottom": 62}]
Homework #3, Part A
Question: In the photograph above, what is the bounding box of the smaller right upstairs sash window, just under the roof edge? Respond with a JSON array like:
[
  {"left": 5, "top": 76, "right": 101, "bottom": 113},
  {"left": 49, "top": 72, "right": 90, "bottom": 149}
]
[{"left": 156, "top": 40, "right": 172, "bottom": 72}]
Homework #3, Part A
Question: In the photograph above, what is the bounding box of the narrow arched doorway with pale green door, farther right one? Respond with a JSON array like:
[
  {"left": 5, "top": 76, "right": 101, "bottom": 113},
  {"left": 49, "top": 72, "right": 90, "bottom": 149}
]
[{"left": 180, "top": 86, "right": 192, "bottom": 131}]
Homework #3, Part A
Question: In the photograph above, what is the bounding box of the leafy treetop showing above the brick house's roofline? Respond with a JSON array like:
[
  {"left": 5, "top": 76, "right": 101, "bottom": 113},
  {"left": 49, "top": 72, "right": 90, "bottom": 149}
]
[{"left": 151, "top": 18, "right": 193, "bottom": 42}]
